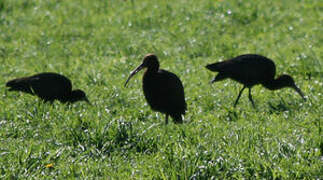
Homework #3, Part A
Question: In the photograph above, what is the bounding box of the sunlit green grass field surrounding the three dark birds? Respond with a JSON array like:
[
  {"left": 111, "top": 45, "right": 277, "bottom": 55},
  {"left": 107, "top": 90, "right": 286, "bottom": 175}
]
[{"left": 0, "top": 0, "right": 323, "bottom": 179}]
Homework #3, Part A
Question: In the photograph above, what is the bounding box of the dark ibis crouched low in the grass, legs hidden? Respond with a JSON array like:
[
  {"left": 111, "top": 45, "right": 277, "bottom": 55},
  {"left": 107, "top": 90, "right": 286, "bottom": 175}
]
[{"left": 6, "top": 73, "right": 89, "bottom": 103}]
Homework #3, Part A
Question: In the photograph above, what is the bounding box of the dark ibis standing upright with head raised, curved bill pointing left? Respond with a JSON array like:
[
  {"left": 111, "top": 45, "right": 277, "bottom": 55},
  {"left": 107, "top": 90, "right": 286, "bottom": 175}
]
[{"left": 125, "top": 54, "right": 186, "bottom": 124}]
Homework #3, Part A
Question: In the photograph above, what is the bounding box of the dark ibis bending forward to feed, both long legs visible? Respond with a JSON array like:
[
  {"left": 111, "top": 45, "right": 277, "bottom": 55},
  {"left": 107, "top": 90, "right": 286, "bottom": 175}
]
[{"left": 206, "top": 54, "right": 305, "bottom": 107}]
